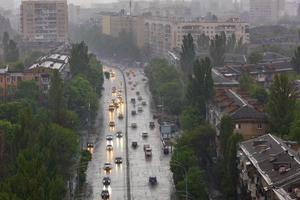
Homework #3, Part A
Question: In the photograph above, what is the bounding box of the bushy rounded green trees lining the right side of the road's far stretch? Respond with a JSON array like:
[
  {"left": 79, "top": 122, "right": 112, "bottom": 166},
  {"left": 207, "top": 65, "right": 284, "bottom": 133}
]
[{"left": 145, "top": 59, "right": 183, "bottom": 115}]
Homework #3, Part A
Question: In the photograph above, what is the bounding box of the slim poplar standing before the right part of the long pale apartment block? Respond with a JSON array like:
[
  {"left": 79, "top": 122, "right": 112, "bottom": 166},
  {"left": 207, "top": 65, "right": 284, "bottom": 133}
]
[{"left": 209, "top": 32, "right": 226, "bottom": 66}]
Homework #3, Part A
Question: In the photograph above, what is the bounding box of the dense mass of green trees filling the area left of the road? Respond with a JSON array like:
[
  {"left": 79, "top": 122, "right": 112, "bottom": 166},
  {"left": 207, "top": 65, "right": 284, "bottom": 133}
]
[{"left": 0, "top": 43, "right": 103, "bottom": 200}]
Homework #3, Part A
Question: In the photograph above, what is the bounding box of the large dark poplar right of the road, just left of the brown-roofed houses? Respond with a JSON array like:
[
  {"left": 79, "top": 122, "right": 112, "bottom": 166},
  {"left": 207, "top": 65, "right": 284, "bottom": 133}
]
[{"left": 187, "top": 57, "right": 213, "bottom": 119}]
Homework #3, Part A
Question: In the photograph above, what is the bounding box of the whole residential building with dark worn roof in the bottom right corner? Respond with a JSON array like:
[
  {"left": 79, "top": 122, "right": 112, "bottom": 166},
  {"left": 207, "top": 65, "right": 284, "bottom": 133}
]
[{"left": 238, "top": 134, "right": 300, "bottom": 200}]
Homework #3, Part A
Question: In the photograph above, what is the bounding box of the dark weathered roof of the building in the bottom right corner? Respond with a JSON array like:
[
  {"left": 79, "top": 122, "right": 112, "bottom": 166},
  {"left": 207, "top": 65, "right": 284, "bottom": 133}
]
[{"left": 240, "top": 134, "right": 300, "bottom": 188}]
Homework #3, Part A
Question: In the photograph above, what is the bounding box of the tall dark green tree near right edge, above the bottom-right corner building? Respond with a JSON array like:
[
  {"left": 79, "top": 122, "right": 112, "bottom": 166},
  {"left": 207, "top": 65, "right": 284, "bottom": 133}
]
[{"left": 267, "top": 74, "right": 296, "bottom": 136}]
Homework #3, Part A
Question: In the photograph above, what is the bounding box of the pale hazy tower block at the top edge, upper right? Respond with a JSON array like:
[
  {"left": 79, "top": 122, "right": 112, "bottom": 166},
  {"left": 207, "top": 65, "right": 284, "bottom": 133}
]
[{"left": 250, "top": 0, "right": 285, "bottom": 24}]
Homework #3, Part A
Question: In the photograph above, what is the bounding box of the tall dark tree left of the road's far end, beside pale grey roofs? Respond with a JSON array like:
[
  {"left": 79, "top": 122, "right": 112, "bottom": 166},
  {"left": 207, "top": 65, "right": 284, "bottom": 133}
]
[{"left": 70, "top": 41, "right": 89, "bottom": 76}]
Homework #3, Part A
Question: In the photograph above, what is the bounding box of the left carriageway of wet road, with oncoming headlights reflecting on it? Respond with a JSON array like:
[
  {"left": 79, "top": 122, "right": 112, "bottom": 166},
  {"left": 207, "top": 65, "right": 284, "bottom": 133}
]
[{"left": 87, "top": 68, "right": 127, "bottom": 200}]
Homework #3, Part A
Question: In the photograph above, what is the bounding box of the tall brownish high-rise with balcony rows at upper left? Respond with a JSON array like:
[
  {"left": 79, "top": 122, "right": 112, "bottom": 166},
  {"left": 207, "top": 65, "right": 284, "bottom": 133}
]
[{"left": 20, "top": 0, "right": 68, "bottom": 42}]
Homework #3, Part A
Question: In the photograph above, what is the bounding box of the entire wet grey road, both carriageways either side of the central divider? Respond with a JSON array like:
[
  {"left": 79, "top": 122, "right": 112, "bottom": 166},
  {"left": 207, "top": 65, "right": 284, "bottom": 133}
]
[{"left": 87, "top": 65, "right": 172, "bottom": 200}]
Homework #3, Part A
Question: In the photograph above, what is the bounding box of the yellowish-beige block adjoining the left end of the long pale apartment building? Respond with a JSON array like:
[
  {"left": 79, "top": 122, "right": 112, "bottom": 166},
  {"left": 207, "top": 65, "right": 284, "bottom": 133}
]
[{"left": 102, "top": 13, "right": 144, "bottom": 48}]
